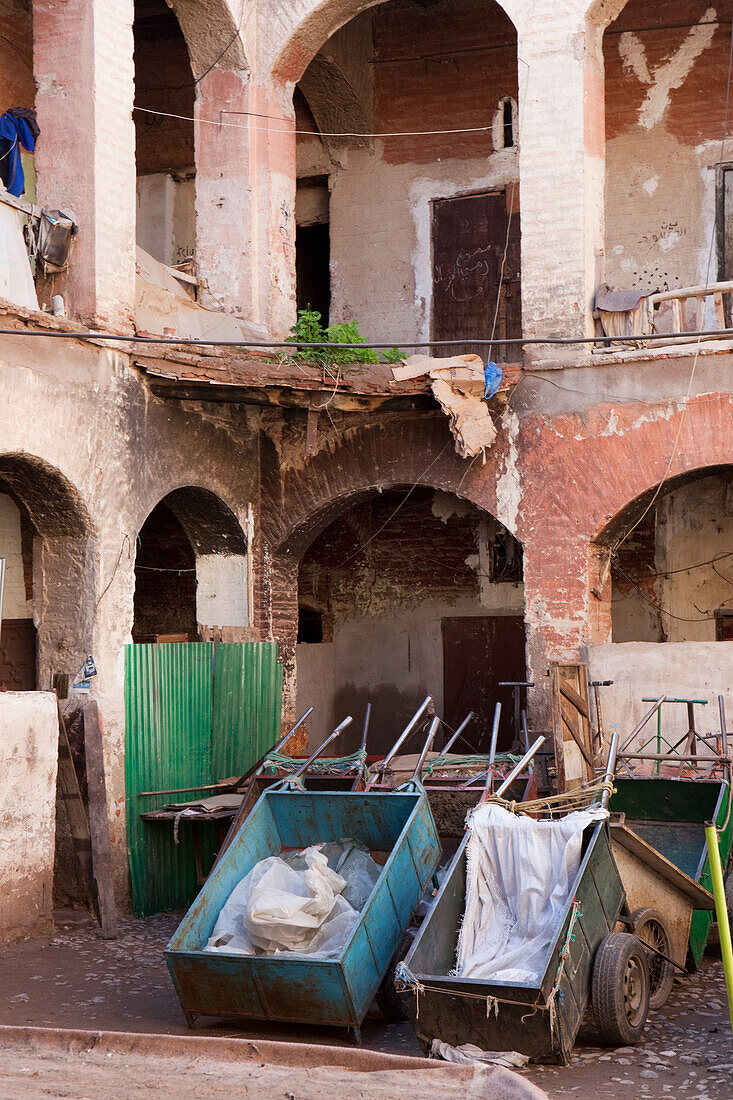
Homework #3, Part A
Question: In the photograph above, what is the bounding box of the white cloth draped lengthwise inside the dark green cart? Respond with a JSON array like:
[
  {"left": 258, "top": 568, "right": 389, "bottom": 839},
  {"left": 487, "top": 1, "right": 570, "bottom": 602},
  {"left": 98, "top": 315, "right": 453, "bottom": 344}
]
[{"left": 456, "top": 803, "right": 608, "bottom": 987}]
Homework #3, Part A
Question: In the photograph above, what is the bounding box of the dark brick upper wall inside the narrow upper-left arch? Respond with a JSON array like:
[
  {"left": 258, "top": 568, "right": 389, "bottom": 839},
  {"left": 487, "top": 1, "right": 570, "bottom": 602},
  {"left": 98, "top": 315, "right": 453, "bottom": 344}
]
[{"left": 134, "top": 9, "right": 195, "bottom": 174}]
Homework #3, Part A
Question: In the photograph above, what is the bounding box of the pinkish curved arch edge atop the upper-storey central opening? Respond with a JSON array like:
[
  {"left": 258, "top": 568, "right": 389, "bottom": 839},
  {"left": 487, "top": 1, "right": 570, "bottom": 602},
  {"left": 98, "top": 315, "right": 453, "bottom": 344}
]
[{"left": 267, "top": 0, "right": 523, "bottom": 84}]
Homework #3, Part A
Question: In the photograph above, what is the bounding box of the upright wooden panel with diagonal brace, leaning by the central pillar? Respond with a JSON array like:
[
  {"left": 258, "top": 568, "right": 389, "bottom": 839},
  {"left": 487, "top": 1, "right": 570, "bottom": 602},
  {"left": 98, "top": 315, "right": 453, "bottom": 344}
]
[{"left": 550, "top": 661, "right": 593, "bottom": 793}]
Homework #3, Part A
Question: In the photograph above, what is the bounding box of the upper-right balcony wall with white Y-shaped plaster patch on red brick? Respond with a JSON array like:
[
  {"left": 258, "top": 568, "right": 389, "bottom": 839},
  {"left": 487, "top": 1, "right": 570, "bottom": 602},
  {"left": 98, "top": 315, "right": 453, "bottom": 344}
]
[{"left": 604, "top": 0, "right": 732, "bottom": 299}]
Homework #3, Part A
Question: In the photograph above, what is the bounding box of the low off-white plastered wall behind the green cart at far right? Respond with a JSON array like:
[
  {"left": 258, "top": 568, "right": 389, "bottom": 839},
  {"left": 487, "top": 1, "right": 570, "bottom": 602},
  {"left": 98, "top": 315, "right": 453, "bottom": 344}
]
[{"left": 587, "top": 641, "right": 733, "bottom": 752}]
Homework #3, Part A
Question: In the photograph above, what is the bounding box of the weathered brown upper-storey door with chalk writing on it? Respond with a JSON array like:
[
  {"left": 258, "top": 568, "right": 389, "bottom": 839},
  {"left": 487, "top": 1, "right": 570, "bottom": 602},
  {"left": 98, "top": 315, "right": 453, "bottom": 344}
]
[{"left": 433, "top": 189, "right": 522, "bottom": 362}]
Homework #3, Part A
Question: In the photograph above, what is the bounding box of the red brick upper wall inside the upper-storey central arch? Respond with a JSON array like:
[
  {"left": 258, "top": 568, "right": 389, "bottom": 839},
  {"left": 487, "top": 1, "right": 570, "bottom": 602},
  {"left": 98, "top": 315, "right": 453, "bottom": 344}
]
[{"left": 373, "top": 0, "right": 517, "bottom": 164}]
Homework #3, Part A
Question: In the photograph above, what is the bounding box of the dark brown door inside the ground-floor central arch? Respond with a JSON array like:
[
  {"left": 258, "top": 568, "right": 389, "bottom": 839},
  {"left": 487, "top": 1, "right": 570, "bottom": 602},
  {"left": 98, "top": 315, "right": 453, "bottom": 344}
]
[{"left": 442, "top": 615, "right": 526, "bottom": 752}]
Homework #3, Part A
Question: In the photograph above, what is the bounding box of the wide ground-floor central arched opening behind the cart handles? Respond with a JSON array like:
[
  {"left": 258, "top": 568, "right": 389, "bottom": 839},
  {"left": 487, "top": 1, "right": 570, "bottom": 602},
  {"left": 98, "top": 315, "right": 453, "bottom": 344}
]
[{"left": 296, "top": 487, "right": 525, "bottom": 752}]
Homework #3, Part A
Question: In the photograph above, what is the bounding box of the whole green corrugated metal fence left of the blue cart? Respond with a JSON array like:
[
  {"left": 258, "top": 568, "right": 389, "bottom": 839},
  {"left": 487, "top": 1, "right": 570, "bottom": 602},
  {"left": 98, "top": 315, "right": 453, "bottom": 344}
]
[{"left": 124, "top": 642, "right": 283, "bottom": 916}]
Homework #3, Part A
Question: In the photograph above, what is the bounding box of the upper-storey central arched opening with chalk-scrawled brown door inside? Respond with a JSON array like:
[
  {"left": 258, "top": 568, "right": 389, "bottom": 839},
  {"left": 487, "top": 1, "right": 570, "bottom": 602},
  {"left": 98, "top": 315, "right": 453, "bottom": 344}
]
[{"left": 294, "top": 0, "right": 522, "bottom": 360}]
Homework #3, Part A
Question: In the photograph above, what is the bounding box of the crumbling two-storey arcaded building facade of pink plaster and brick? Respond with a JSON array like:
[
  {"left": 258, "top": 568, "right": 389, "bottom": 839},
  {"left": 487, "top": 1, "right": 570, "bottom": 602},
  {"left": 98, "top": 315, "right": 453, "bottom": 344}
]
[{"left": 0, "top": 0, "right": 733, "bottom": 935}]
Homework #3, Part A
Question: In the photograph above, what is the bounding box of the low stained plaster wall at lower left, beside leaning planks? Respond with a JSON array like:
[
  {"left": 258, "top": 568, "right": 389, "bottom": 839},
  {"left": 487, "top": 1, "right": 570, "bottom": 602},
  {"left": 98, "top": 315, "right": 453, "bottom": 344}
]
[{"left": 0, "top": 692, "right": 58, "bottom": 942}]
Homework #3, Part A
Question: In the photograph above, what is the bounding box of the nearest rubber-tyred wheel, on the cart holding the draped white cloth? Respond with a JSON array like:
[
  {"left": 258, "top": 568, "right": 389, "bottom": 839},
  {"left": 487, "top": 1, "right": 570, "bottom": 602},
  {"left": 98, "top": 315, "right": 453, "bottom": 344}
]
[{"left": 591, "top": 932, "right": 649, "bottom": 1046}]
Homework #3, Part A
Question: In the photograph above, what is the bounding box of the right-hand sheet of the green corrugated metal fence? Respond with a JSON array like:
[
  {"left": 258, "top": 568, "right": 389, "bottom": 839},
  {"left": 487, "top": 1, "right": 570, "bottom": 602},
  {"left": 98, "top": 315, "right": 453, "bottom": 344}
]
[{"left": 211, "top": 641, "right": 283, "bottom": 778}]
